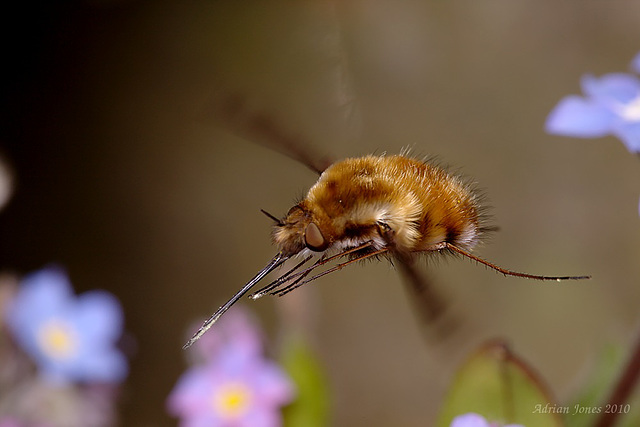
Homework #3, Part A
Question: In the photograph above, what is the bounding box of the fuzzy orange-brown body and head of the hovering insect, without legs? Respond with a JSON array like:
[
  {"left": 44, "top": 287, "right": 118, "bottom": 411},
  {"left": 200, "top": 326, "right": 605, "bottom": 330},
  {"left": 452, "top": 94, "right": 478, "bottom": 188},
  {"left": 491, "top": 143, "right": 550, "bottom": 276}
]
[{"left": 273, "top": 155, "right": 482, "bottom": 255}]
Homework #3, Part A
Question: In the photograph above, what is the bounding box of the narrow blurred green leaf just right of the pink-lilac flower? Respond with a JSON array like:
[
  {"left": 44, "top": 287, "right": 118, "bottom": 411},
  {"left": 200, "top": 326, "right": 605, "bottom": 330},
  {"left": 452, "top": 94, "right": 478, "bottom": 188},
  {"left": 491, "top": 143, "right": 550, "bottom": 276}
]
[{"left": 281, "top": 337, "right": 329, "bottom": 427}]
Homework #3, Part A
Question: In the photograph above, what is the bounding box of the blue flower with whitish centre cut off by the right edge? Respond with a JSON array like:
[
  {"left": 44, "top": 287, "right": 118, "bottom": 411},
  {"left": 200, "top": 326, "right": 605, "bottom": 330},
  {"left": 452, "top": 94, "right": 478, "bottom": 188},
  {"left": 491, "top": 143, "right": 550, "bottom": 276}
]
[{"left": 545, "top": 54, "right": 640, "bottom": 153}]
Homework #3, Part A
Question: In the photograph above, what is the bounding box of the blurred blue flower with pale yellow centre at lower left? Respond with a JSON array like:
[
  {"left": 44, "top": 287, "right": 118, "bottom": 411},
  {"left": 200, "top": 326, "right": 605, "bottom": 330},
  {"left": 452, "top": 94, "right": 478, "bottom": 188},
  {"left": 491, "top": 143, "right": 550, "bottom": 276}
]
[{"left": 5, "top": 268, "right": 128, "bottom": 383}]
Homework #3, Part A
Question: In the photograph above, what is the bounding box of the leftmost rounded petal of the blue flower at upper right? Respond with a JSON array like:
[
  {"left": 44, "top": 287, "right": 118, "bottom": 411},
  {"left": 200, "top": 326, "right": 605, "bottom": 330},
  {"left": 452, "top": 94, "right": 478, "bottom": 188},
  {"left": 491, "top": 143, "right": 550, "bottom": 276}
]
[{"left": 545, "top": 96, "right": 615, "bottom": 138}]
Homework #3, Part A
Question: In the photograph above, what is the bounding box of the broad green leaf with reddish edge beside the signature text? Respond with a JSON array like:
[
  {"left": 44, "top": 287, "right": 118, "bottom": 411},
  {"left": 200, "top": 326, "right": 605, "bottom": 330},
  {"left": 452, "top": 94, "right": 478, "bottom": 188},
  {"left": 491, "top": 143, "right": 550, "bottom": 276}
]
[{"left": 437, "top": 341, "right": 570, "bottom": 427}]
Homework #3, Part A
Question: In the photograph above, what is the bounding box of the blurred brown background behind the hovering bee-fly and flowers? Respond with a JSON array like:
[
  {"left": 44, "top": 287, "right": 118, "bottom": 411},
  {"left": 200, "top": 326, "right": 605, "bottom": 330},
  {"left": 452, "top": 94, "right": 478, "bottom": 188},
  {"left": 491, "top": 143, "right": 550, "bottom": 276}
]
[{"left": 0, "top": 0, "right": 640, "bottom": 426}]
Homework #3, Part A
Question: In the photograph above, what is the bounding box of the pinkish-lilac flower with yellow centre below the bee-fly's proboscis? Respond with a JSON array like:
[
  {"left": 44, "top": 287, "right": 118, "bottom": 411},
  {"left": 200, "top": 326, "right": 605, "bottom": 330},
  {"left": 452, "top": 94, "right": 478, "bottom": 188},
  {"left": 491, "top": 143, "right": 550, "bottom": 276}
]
[{"left": 167, "top": 310, "right": 294, "bottom": 427}]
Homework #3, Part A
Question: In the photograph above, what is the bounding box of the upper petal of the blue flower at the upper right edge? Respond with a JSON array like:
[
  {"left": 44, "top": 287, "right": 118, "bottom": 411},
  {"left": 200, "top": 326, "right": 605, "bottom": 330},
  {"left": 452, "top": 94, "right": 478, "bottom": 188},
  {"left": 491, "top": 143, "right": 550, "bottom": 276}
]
[{"left": 580, "top": 73, "right": 640, "bottom": 105}]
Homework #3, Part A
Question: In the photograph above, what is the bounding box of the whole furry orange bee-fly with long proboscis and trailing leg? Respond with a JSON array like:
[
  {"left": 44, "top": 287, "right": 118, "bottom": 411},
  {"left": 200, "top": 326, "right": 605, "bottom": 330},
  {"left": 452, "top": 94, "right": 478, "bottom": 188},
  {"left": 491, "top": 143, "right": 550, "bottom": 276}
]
[{"left": 183, "top": 155, "right": 589, "bottom": 348}]
